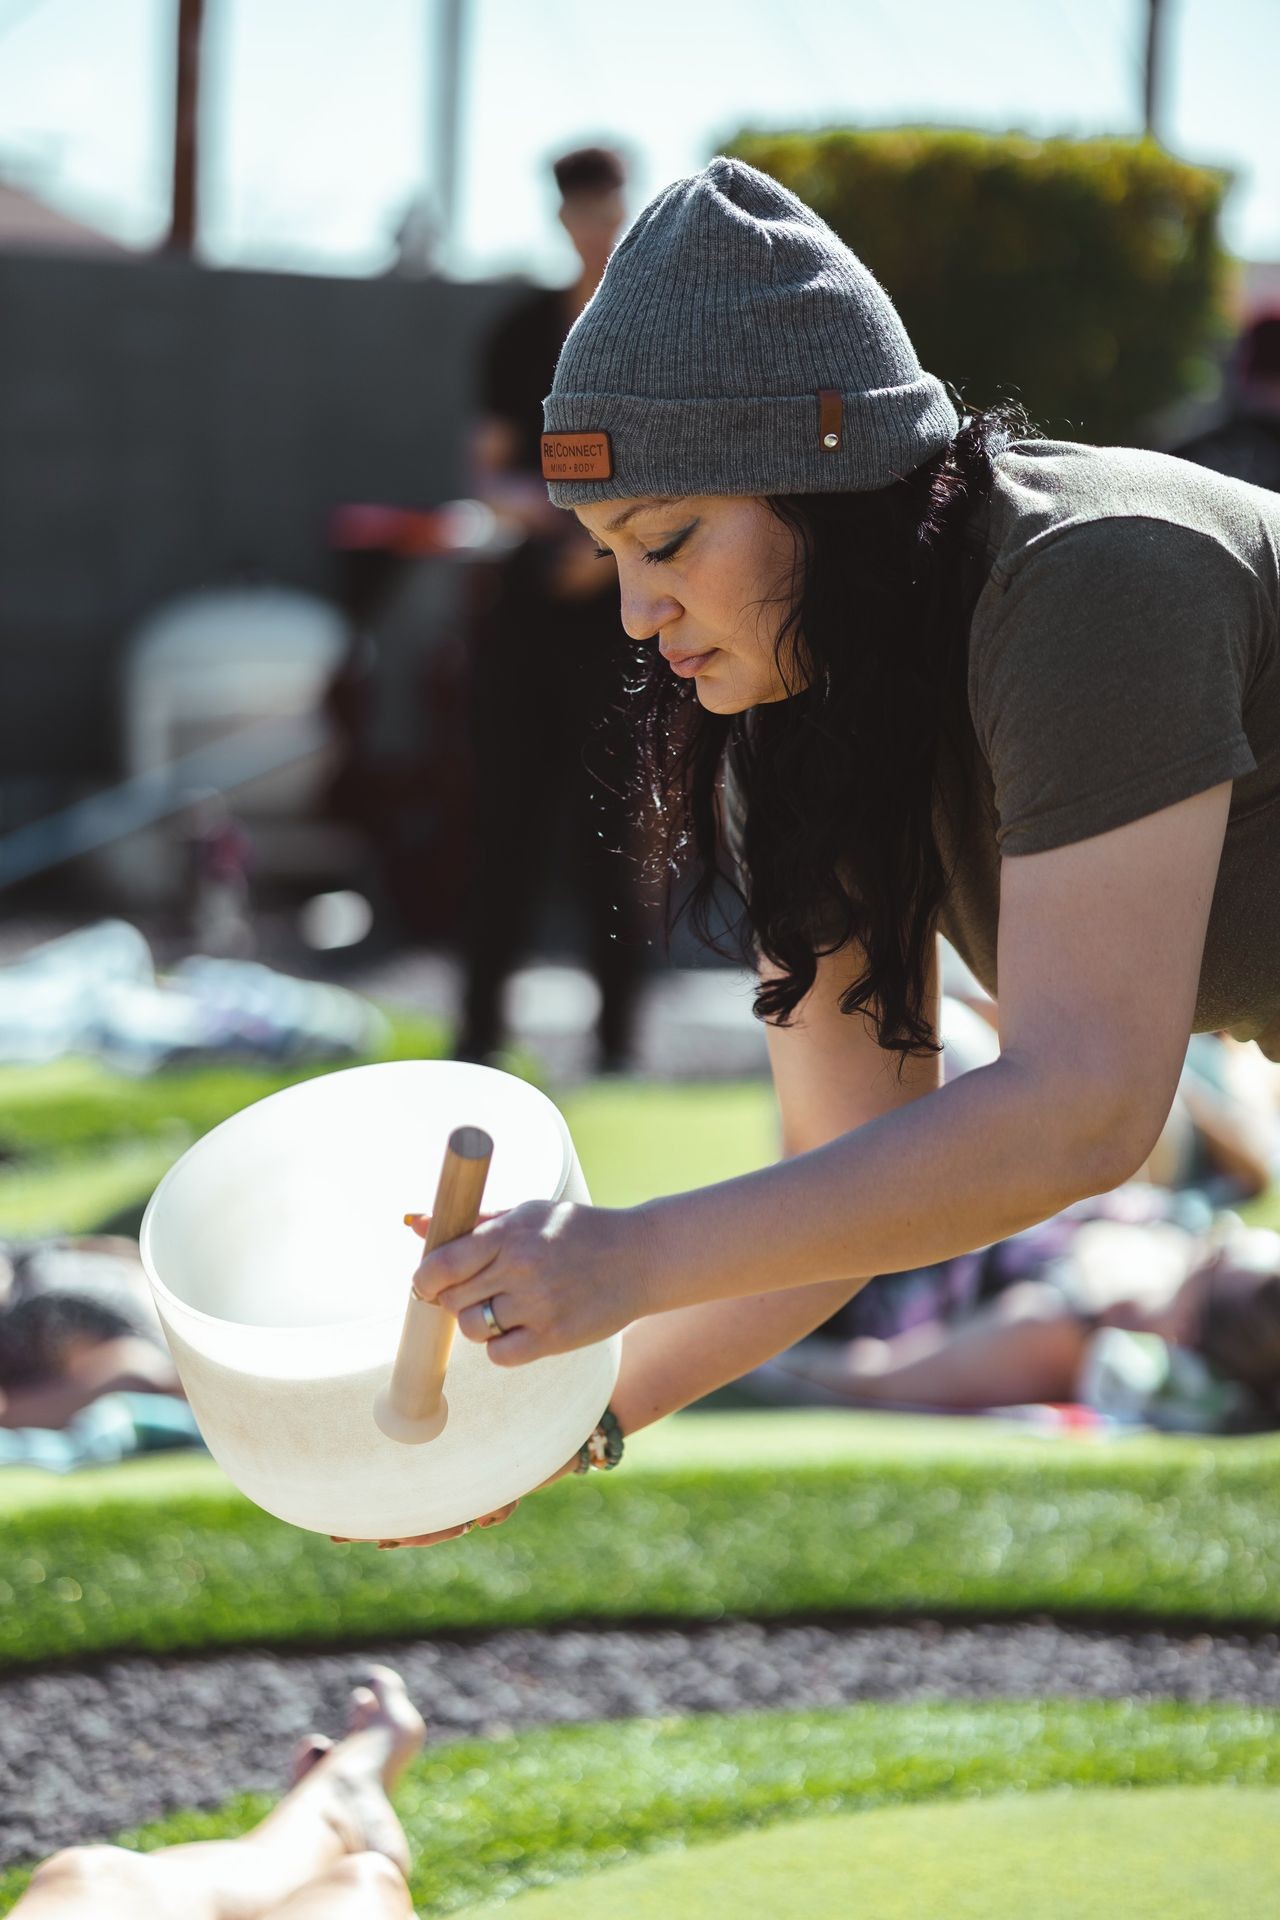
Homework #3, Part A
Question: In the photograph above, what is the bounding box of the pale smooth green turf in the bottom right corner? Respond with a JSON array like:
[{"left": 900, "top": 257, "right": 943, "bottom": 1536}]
[{"left": 466, "top": 1788, "right": 1280, "bottom": 1920}]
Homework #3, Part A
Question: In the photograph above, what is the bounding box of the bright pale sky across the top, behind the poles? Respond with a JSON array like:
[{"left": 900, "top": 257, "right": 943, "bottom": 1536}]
[{"left": 0, "top": 0, "right": 1280, "bottom": 280}]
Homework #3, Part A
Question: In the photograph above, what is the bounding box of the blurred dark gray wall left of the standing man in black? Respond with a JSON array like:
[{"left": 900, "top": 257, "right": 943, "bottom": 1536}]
[{"left": 0, "top": 255, "right": 514, "bottom": 810}]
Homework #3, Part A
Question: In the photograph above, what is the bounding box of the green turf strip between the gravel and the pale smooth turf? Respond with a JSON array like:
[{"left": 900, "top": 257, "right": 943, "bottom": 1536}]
[{"left": 0, "top": 1701, "right": 1280, "bottom": 1920}]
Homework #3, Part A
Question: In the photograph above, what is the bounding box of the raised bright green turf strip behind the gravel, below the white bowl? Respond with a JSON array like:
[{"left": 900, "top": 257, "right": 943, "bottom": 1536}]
[{"left": 0, "top": 1411, "right": 1280, "bottom": 1665}]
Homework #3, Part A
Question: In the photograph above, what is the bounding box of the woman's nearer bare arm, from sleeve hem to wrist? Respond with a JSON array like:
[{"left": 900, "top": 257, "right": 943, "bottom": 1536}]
[{"left": 637, "top": 783, "right": 1230, "bottom": 1320}]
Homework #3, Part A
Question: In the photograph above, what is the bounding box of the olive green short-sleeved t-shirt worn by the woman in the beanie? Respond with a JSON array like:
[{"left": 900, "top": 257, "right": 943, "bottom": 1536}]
[{"left": 938, "top": 440, "right": 1280, "bottom": 1058}]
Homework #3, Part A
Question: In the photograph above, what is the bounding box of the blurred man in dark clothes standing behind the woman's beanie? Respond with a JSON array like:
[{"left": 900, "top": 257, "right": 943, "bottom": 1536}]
[{"left": 457, "top": 148, "right": 641, "bottom": 1071}]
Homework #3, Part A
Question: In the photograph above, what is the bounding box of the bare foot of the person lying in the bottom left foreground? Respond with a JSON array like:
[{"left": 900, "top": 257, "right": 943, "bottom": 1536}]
[{"left": 308, "top": 1667, "right": 426, "bottom": 1874}]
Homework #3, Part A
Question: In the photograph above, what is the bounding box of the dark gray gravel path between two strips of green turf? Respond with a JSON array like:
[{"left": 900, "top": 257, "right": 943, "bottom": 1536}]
[{"left": 0, "top": 1620, "right": 1280, "bottom": 1864}]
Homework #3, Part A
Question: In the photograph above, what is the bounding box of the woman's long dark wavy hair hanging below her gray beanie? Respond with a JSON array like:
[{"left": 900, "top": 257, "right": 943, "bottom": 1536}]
[{"left": 626, "top": 407, "right": 1032, "bottom": 1054}]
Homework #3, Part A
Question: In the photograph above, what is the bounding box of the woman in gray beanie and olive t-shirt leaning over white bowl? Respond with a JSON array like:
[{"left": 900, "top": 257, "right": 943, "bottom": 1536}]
[{"left": 402, "top": 159, "right": 1280, "bottom": 1528}]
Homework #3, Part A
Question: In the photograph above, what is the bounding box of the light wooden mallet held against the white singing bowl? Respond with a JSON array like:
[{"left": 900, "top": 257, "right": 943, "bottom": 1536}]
[{"left": 374, "top": 1127, "right": 493, "bottom": 1446}]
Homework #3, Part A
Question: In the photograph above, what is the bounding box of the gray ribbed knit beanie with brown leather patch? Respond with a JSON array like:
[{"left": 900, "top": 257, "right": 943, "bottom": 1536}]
[{"left": 543, "top": 157, "right": 960, "bottom": 507}]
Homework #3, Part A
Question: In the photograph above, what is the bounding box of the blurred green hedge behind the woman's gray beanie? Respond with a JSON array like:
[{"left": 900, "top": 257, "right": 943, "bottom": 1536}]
[{"left": 729, "top": 129, "right": 1228, "bottom": 442}]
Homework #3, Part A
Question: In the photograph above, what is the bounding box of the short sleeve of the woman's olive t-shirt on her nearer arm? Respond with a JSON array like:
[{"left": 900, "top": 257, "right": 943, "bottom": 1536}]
[{"left": 969, "top": 518, "right": 1261, "bottom": 854}]
